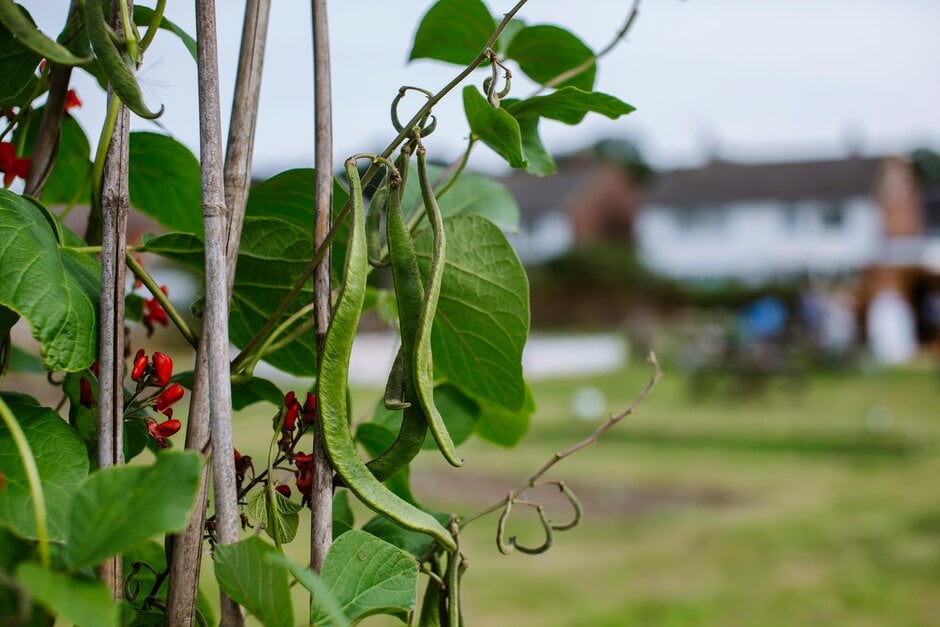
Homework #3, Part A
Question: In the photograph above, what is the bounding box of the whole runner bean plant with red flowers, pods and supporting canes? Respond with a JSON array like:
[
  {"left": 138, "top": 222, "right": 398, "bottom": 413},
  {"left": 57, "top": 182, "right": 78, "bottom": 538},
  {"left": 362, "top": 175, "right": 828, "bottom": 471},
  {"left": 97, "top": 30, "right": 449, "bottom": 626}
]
[{"left": 0, "top": 0, "right": 659, "bottom": 627}]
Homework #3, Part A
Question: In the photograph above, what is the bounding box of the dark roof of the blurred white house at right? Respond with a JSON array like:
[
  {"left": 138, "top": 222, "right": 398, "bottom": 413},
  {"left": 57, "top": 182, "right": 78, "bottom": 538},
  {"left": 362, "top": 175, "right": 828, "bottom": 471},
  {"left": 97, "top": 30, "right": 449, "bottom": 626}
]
[{"left": 646, "top": 157, "right": 883, "bottom": 207}]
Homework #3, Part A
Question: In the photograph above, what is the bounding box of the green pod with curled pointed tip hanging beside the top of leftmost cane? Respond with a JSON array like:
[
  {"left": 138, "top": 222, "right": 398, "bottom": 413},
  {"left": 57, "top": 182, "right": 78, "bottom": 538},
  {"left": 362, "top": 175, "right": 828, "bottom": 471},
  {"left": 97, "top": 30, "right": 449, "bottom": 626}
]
[{"left": 83, "top": 0, "right": 163, "bottom": 120}]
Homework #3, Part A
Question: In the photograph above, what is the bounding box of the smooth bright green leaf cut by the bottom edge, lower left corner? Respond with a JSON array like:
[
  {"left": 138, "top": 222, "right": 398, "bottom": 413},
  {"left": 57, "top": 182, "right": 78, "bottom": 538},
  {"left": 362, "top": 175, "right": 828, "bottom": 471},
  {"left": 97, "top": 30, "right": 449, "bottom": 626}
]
[{"left": 16, "top": 562, "right": 118, "bottom": 627}]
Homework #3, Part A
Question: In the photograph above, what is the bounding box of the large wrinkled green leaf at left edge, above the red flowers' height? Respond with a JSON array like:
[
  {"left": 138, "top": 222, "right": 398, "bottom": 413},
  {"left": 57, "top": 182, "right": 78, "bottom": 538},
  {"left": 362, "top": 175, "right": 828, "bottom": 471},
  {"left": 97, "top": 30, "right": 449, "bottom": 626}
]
[{"left": 0, "top": 190, "right": 100, "bottom": 372}]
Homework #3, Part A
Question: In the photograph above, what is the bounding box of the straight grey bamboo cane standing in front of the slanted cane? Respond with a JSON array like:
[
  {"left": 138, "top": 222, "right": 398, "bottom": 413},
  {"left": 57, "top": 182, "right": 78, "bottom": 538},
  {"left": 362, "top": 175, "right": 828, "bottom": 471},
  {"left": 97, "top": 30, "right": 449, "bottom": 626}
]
[{"left": 196, "top": 0, "right": 245, "bottom": 625}]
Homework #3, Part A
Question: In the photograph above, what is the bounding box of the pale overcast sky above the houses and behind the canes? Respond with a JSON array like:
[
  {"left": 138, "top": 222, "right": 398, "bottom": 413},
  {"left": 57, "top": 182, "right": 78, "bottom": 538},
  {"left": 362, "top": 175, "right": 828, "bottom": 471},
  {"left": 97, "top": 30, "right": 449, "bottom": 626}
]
[{"left": 22, "top": 0, "right": 940, "bottom": 175}]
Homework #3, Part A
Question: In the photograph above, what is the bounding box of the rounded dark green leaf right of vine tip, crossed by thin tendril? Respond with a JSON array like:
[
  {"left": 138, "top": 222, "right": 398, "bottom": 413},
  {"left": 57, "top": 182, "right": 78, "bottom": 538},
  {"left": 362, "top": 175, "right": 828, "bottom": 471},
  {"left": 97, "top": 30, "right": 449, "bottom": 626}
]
[{"left": 506, "top": 24, "right": 597, "bottom": 91}]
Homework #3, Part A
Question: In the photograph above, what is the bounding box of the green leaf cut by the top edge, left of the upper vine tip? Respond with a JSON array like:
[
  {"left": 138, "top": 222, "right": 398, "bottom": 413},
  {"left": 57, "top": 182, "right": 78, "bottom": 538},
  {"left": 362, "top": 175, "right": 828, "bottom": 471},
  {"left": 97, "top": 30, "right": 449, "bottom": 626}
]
[{"left": 408, "top": 0, "right": 495, "bottom": 65}]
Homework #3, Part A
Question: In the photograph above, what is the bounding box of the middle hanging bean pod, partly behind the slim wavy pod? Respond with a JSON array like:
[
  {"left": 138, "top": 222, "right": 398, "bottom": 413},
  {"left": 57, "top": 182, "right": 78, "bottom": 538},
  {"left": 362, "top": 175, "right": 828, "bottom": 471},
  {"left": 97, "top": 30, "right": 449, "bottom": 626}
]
[{"left": 368, "top": 150, "right": 428, "bottom": 481}]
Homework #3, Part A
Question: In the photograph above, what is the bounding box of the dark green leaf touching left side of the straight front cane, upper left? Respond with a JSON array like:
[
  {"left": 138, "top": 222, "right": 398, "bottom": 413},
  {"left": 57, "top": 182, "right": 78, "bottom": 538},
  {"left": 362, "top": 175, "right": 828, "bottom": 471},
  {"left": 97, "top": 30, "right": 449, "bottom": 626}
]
[{"left": 128, "top": 132, "right": 202, "bottom": 234}]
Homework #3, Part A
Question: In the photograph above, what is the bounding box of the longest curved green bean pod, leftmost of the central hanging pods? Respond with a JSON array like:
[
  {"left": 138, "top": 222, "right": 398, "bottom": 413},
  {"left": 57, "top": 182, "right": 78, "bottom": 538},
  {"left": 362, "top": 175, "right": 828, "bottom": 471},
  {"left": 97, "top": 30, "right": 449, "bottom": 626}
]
[{"left": 317, "top": 159, "right": 455, "bottom": 550}]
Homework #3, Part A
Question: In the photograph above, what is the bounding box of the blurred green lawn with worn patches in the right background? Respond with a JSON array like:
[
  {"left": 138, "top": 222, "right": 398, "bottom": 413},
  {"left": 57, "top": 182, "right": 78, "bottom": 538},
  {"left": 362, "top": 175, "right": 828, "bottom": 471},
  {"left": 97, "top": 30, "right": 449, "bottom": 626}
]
[{"left": 222, "top": 365, "right": 940, "bottom": 626}]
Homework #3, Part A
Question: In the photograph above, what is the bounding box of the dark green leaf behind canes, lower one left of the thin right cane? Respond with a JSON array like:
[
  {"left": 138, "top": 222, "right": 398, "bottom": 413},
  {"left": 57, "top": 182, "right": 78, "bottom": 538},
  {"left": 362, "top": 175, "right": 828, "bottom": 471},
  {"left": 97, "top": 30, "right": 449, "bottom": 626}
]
[{"left": 145, "top": 217, "right": 316, "bottom": 376}]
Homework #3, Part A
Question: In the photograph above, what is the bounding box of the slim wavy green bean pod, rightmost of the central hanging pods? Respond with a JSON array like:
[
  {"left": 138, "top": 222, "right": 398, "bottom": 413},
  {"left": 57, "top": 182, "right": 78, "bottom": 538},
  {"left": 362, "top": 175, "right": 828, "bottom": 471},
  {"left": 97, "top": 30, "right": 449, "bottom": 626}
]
[{"left": 414, "top": 145, "right": 463, "bottom": 466}]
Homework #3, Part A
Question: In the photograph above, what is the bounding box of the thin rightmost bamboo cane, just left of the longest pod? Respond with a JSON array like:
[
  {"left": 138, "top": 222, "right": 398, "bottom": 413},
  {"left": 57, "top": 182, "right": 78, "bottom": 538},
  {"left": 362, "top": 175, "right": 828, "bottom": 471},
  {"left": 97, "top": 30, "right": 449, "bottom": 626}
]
[{"left": 308, "top": 0, "right": 333, "bottom": 576}]
